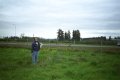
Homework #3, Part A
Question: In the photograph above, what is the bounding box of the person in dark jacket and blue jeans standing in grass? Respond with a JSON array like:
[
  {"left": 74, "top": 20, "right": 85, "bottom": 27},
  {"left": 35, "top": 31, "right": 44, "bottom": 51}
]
[{"left": 32, "top": 37, "right": 40, "bottom": 64}]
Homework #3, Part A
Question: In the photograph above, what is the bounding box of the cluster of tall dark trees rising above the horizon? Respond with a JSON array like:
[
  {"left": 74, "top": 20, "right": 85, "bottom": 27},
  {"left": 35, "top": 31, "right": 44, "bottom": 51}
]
[{"left": 57, "top": 29, "right": 81, "bottom": 41}]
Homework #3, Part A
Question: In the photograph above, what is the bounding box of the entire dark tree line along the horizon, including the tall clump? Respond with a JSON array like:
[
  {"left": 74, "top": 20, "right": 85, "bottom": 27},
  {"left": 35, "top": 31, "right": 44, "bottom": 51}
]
[{"left": 0, "top": 29, "right": 120, "bottom": 44}]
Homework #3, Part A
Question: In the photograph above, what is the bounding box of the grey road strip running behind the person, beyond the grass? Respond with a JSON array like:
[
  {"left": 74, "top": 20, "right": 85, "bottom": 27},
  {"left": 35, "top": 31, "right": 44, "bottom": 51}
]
[{"left": 0, "top": 42, "right": 120, "bottom": 48}]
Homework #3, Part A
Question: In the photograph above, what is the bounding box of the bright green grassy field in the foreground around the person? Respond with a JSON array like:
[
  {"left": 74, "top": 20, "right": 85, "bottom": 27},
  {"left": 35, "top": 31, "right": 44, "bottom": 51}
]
[{"left": 0, "top": 47, "right": 120, "bottom": 80}]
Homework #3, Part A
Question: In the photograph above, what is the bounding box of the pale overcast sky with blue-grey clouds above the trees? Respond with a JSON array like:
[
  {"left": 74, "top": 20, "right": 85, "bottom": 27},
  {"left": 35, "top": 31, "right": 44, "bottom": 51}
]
[{"left": 0, "top": 0, "right": 120, "bottom": 38}]
